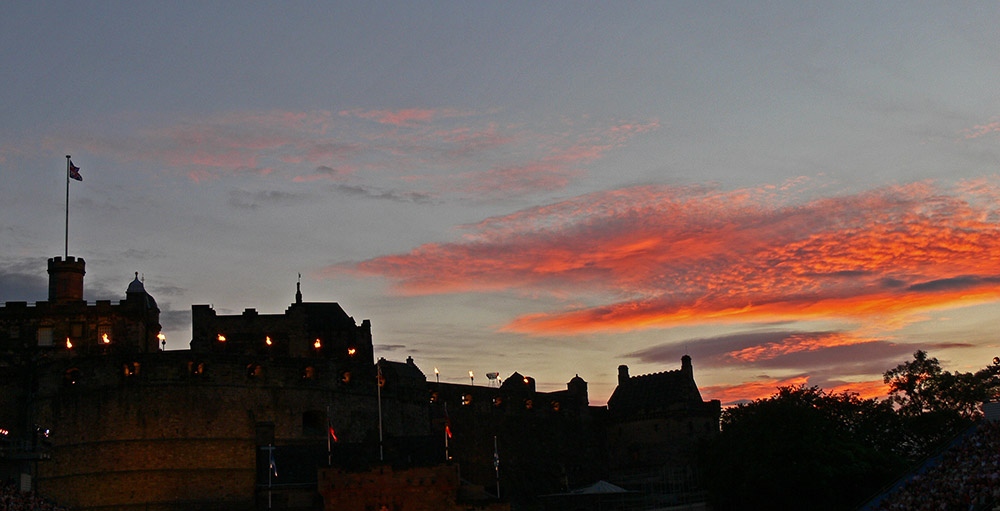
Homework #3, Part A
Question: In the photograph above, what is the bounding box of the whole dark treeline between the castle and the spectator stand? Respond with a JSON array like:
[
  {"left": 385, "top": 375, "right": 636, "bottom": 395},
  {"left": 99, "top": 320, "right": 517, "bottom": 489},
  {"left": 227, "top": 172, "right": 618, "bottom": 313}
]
[{"left": 701, "top": 351, "right": 1000, "bottom": 511}]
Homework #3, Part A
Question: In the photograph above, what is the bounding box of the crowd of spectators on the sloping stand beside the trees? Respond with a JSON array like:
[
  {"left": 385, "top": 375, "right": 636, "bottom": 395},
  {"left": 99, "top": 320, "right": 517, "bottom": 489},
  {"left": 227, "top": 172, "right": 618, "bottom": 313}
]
[{"left": 876, "top": 421, "right": 1000, "bottom": 511}]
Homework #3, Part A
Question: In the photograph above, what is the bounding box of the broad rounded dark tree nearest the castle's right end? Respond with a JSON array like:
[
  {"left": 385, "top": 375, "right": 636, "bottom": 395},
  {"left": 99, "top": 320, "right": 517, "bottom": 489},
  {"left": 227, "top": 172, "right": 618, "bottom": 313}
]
[{"left": 703, "top": 386, "right": 906, "bottom": 510}]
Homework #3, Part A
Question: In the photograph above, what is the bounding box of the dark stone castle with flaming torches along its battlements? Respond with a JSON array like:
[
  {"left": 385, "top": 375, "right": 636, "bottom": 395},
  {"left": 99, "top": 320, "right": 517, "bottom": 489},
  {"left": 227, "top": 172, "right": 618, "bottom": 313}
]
[{"left": 0, "top": 257, "right": 720, "bottom": 511}]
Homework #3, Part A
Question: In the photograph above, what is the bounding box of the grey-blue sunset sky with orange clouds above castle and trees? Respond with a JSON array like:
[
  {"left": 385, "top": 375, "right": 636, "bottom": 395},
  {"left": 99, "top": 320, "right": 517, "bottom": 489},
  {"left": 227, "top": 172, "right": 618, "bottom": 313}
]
[{"left": 0, "top": 0, "right": 1000, "bottom": 404}]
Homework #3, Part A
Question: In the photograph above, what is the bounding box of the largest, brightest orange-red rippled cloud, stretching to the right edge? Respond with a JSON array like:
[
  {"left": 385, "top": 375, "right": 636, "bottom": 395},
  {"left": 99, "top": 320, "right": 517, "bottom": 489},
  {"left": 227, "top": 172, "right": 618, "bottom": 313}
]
[{"left": 331, "top": 181, "right": 1000, "bottom": 334}]
